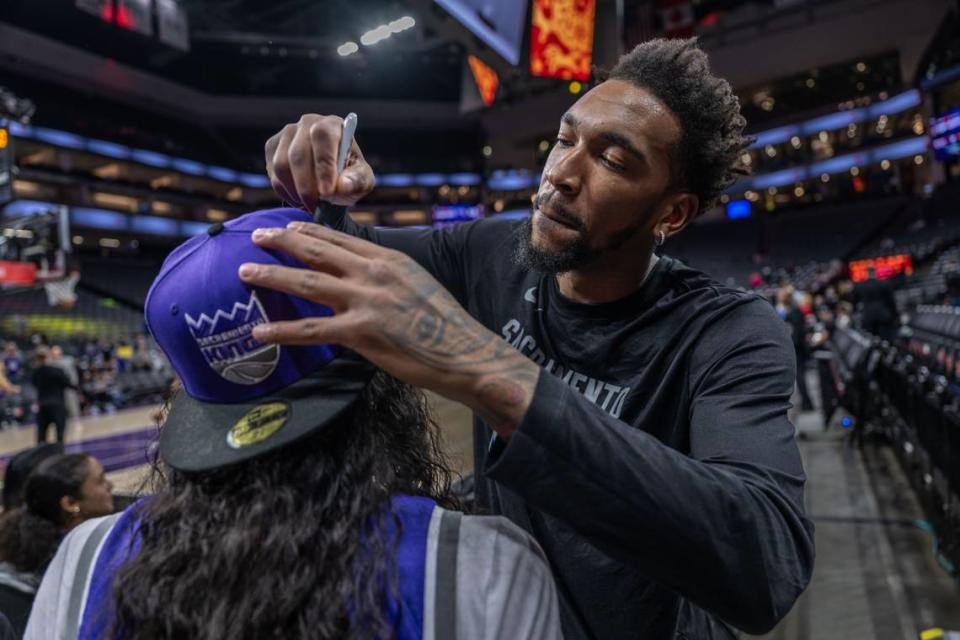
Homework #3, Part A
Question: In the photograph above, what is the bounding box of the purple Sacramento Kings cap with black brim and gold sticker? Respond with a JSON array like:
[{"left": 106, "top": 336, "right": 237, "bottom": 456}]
[{"left": 145, "top": 209, "right": 375, "bottom": 471}]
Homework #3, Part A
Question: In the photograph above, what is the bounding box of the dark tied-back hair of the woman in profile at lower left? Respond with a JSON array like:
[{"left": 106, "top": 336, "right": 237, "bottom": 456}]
[{"left": 0, "top": 453, "right": 90, "bottom": 574}]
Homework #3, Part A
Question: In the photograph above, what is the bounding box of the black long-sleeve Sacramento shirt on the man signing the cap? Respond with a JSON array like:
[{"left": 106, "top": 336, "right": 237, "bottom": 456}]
[{"left": 334, "top": 218, "right": 814, "bottom": 640}]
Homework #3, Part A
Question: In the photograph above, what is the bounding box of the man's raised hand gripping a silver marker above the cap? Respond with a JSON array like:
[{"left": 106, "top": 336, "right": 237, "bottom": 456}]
[{"left": 264, "top": 114, "right": 374, "bottom": 213}]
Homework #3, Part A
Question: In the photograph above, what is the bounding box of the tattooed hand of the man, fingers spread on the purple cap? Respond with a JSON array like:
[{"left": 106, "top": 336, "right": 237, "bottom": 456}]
[{"left": 240, "top": 222, "right": 540, "bottom": 438}]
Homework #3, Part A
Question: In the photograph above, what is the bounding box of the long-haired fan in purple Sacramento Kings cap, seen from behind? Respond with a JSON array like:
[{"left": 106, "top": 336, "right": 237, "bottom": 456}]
[{"left": 26, "top": 210, "right": 560, "bottom": 640}]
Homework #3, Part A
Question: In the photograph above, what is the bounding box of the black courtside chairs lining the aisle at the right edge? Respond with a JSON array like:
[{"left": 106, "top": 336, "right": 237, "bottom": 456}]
[{"left": 820, "top": 318, "right": 960, "bottom": 566}]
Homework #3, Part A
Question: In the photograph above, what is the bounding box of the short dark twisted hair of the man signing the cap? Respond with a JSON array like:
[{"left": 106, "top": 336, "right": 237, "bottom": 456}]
[{"left": 608, "top": 38, "right": 752, "bottom": 212}]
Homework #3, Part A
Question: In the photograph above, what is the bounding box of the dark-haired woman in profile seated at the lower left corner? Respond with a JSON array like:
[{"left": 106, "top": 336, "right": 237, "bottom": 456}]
[{"left": 0, "top": 453, "right": 113, "bottom": 637}]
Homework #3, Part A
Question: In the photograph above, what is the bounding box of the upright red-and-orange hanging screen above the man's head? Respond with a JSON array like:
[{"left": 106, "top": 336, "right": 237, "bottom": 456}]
[{"left": 530, "top": 0, "right": 596, "bottom": 80}]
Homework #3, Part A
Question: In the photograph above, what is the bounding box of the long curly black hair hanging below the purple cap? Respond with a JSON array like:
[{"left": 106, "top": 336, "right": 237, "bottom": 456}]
[{"left": 109, "top": 372, "right": 458, "bottom": 640}]
